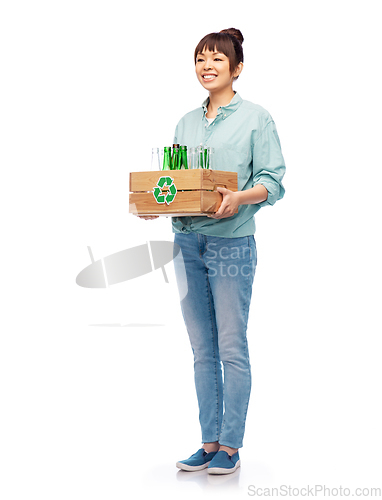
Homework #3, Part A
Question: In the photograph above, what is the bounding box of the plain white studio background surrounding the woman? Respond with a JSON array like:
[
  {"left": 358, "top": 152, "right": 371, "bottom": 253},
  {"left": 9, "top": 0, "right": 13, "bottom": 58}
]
[{"left": 0, "top": 0, "right": 382, "bottom": 500}]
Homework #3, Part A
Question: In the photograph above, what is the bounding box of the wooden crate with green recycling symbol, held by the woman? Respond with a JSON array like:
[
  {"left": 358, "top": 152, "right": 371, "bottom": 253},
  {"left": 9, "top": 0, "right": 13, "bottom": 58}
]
[{"left": 129, "top": 169, "right": 237, "bottom": 217}]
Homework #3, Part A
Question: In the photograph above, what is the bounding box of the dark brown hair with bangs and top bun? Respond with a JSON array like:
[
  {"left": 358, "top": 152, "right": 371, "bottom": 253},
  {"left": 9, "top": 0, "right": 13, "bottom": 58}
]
[{"left": 194, "top": 28, "right": 244, "bottom": 77}]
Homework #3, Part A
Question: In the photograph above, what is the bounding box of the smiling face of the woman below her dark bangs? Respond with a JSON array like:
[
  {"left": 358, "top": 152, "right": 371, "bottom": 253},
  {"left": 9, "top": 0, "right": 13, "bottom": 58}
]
[{"left": 195, "top": 48, "right": 243, "bottom": 92}]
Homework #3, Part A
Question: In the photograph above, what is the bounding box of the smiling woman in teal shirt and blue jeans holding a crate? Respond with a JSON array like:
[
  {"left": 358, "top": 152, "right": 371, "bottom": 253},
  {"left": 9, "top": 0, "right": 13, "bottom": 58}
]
[{"left": 140, "top": 28, "right": 285, "bottom": 474}]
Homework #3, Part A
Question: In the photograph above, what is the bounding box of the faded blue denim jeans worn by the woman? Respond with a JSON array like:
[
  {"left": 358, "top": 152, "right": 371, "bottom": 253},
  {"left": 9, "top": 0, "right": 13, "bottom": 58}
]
[{"left": 174, "top": 232, "right": 257, "bottom": 448}]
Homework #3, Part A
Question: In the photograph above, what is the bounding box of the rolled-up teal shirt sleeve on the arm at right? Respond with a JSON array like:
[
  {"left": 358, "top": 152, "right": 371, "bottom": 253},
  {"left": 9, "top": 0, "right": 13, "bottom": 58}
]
[{"left": 252, "top": 120, "right": 285, "bottom": 207}]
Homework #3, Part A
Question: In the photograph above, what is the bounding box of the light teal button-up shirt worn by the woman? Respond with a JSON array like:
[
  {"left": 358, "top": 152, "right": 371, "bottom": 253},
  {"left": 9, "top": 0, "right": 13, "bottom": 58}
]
[{"left": 172, "top": 93, "right": 285, "bottom": 238}]
